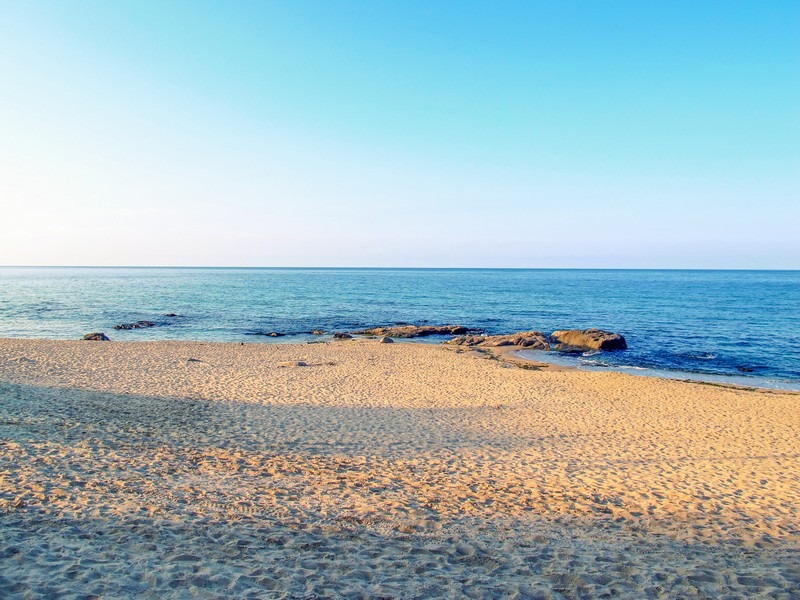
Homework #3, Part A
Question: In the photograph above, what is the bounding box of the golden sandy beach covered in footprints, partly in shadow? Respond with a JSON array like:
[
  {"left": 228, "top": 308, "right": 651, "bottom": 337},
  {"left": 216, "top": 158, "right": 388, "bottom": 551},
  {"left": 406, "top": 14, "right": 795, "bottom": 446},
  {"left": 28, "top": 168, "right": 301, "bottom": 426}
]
[{"left": 0, "top": 339, "right": 800, "bottom": 598}]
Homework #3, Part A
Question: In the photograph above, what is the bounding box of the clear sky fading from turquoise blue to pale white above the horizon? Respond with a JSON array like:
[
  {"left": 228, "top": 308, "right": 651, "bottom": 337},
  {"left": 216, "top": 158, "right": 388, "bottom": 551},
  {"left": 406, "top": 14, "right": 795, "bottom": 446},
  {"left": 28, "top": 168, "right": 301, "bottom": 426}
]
[{"left": 0, "top": 0, "right": 800, "bottom": 269}]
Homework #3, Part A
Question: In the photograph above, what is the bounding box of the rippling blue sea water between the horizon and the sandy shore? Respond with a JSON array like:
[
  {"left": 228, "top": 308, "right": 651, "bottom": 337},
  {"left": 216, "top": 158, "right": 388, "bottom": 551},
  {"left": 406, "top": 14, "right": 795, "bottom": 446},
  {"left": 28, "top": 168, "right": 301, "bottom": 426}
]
[{"left": 0, "top": 267, "right": 800, "bottom": 389}]
